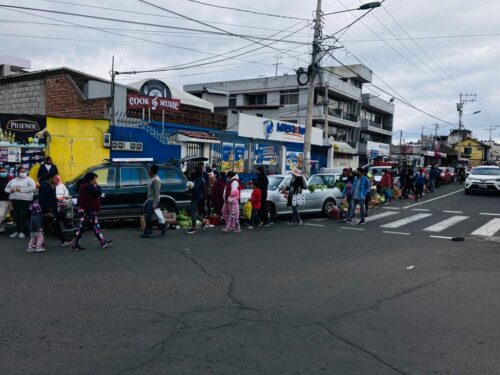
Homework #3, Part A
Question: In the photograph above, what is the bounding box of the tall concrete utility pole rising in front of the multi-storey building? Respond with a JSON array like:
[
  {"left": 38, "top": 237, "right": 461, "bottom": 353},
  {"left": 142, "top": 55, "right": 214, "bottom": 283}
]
[{"left": 303, "top": 0, "right": 322, "bottom": 177}]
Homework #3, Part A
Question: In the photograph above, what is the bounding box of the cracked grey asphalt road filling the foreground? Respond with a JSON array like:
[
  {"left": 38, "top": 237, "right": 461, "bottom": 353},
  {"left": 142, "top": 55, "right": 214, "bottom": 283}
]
[{"left": 0, "top": 185, "right": 500, "bottom": 375}]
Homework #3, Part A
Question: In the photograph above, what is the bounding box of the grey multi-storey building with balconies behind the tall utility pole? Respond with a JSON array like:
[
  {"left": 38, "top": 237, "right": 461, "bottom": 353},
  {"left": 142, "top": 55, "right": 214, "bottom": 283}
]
[{"left": 184, "top": 65, "right": 394, "bottom": 166}]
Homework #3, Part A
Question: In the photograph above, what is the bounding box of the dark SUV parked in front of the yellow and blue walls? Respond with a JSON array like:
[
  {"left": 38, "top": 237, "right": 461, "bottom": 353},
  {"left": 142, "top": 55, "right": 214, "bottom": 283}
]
[{"left": 66, "top": 161, "right": 190, "bottom": 219}]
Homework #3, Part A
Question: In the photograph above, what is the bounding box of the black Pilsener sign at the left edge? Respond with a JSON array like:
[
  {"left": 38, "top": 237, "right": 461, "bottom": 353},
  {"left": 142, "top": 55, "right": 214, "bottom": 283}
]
[{"left": 0, "top": 113, "right": 47, "bottom": 144}]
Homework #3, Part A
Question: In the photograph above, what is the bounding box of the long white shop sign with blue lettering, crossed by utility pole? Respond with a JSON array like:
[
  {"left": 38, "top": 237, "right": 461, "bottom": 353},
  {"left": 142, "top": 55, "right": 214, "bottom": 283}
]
[{"left": 238, "top": 113, "right": 323, "bottom": 146}]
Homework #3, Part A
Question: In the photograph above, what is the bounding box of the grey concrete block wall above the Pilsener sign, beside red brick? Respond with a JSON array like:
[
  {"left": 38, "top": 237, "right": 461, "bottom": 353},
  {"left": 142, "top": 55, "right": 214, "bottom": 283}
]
[{"left": 0, "top": 79, "right": 45, "bottom": 115}]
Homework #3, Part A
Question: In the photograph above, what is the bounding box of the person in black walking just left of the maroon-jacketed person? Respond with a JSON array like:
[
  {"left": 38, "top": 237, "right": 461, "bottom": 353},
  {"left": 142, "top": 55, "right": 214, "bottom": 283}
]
[{"left": 38, "top": 172, "right": 72, "bottom": 246}]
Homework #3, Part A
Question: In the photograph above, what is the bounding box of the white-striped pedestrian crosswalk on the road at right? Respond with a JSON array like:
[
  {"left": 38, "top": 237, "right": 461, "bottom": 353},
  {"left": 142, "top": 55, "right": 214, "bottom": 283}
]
[{"left": 346, "top": 209, "right": 500, "bottom": 238}]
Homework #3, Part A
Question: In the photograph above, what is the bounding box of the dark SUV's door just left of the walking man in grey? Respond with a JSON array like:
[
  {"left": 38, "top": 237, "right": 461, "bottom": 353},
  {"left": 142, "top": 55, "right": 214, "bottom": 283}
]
[{"left": 117, "top": 166, "right": 149, "bottom": 217}]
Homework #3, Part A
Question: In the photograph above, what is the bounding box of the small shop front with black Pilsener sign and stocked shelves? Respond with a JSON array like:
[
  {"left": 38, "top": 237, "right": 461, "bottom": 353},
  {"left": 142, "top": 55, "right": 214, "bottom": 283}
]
[{"left": 0, "top": 114, "right": 46, "bottom": 176}]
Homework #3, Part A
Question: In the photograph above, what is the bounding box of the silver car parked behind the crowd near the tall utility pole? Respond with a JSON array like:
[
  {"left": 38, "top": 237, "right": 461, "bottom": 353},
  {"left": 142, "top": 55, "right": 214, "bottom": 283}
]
[{"left": 241, "top": 174, "right": 343, "bottom": 216}]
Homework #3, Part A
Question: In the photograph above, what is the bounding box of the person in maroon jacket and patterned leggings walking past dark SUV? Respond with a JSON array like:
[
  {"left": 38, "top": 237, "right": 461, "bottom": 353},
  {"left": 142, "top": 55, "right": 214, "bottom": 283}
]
[{"left": 72, "top": 172, "right": 113, "bottom": 251}]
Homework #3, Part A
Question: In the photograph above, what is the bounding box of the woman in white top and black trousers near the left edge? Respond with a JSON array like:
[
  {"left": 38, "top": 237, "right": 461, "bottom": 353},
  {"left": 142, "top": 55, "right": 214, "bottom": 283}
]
[{"left": 5, "top": 167, "right": 36, "bottom": 238}]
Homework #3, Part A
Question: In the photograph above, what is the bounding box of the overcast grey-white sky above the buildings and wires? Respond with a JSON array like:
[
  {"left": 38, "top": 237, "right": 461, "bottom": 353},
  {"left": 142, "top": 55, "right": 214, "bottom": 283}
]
[{"left": 0, "top": 0, "right": 500, "bottom": 141}]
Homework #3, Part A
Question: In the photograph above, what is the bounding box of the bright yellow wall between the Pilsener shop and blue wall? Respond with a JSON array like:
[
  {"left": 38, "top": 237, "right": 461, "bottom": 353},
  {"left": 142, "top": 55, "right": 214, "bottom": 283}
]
[{"left": 43, "top": 117, "right": 110, "bottom": 181}]
